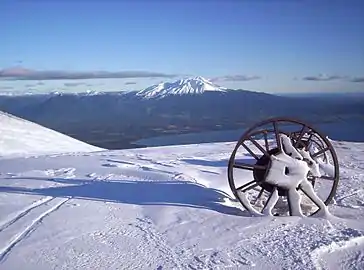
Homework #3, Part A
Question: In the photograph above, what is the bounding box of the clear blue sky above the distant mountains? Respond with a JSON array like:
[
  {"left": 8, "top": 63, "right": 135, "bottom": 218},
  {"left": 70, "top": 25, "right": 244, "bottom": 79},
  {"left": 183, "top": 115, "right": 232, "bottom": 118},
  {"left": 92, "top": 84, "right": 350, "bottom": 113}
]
[{"left": 0, "top": 0, "right": 364, "bottom": 92}]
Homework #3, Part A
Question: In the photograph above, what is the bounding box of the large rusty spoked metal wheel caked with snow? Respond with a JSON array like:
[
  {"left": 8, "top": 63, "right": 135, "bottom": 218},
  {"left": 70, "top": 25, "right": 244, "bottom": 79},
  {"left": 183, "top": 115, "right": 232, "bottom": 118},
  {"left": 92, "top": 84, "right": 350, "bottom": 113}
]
[{"left": 228, "top": 118, "right": 339, "bottom": 216}]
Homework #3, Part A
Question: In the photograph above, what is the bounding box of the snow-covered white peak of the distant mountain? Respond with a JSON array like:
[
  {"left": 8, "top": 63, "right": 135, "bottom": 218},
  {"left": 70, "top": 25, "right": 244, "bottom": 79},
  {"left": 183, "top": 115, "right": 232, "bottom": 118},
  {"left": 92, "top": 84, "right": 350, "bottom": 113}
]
[{"left": 136, "top": 76, "right": 227, "bottom": 98}]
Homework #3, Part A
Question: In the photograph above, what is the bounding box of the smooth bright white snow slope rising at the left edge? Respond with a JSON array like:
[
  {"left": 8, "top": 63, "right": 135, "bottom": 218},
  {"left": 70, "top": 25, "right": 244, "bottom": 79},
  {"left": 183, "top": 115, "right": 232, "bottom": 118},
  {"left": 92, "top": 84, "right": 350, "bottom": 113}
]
[{"left": 0, "top": 111, "right": 103, "bottom": 157}]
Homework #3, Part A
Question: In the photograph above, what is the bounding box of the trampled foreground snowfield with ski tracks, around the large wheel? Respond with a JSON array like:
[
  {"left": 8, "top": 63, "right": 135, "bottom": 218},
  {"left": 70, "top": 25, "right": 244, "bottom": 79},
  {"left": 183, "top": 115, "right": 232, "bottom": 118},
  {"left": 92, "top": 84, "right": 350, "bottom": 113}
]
[{"left": 0, "top": 115, "right": 364, "bottom": 270}]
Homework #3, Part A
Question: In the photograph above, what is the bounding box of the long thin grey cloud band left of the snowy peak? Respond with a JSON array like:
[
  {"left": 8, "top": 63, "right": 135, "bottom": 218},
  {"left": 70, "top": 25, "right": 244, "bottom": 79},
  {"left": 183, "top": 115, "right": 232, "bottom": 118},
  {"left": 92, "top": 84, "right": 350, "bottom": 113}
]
[{"left": 0, "top": 68, "right": 178, "bottom": 80}]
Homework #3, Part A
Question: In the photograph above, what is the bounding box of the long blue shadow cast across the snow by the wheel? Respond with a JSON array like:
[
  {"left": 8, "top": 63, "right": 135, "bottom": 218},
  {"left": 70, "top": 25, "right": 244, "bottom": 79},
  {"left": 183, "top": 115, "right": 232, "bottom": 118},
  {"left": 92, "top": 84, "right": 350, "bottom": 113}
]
[{"left": 0, "top": 177, "right": 246, "bottom": 216}]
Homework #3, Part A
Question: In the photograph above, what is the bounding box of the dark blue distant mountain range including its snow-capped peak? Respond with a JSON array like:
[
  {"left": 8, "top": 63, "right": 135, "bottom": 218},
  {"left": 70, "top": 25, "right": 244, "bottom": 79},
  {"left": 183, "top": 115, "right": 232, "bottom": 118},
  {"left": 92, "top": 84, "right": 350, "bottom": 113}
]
[{"left": 0, "top": 77, "right": 364, "bottom": 149}]
